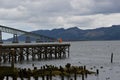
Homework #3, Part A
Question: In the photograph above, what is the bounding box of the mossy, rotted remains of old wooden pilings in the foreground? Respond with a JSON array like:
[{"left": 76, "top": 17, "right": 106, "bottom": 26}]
[{"left": 0, "top": 64, "right": 95, "bottom": 80}]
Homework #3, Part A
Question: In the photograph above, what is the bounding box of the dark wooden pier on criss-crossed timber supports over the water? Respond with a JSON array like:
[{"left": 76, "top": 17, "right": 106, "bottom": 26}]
[{"left": 0, "top": 43, "right": 70, "bottom": 63}]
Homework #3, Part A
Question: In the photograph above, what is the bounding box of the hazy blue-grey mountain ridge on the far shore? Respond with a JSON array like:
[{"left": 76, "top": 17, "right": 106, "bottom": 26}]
[{"left": 5, "top": 25, "right": 120, "bottom": 41}]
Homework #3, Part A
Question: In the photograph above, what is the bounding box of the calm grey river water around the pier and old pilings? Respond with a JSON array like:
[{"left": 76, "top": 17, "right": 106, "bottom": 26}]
[{"left": 1, "top": 41, "right": 120, "bottom": 80}]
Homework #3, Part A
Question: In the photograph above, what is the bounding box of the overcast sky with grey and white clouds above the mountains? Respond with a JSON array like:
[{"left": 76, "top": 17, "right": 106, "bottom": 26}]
[{"left": 0, "top": 0, "right": 120, "bottom": 38}]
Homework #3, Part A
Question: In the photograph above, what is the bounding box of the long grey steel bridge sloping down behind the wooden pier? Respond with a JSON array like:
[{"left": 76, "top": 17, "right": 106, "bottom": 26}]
[{"left": 0, "top": 25, "right": 56, "bottom": 43}]
